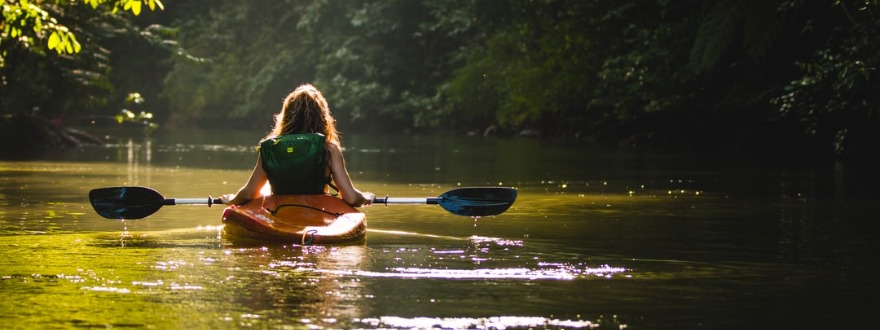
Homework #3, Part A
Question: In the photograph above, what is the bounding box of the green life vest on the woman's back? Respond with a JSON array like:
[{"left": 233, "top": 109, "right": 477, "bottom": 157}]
[{"left": 260, "top": 133, "right": 330, "bottom": 195}]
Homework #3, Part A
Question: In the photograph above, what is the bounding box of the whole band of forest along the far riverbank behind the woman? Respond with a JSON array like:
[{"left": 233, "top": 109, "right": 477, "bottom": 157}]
[{"left": 0, "top": 0, "right": 880, "bottom": 159}]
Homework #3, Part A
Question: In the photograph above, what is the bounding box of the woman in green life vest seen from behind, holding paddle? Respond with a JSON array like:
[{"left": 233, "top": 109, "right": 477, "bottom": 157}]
[{"left": 220, "top": 84, "right": 375, "bottom": 207}]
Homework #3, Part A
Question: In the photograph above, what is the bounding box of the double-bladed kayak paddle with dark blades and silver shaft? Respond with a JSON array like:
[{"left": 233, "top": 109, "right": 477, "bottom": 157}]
[{"left": 89, "top": 187, "right": 516, "bottom": 219}]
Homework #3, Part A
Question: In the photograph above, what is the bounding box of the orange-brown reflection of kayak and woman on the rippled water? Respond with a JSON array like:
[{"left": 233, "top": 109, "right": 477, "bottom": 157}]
[{"left": 224, "top": 245, "right": 367, "bottom": 326}]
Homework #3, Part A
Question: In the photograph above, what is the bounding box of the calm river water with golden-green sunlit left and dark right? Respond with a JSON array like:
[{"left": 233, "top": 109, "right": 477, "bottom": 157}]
[{"left": 0, "top": 127, "right": 880, "bottom": 329}]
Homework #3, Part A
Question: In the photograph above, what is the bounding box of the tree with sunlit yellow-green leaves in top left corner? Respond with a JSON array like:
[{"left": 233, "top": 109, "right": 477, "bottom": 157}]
[{"left": 0, "top": 0, "right": 172, "bottom": 115}]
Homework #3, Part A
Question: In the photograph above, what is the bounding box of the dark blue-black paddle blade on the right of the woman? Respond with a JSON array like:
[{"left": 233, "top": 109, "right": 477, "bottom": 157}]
[{"left": 437, "top": 187, "right": 516, "bottom": 217}]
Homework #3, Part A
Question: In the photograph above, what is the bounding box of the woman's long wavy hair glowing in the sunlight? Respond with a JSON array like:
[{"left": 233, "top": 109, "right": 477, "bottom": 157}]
[{"left": 264, "top": 84, "right": 339, "bottom": 145}]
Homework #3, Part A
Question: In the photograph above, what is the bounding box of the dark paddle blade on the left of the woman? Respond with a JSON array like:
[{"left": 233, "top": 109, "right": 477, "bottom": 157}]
[{"left": 89, "top": 187, "right": 165, "bottom": 220}]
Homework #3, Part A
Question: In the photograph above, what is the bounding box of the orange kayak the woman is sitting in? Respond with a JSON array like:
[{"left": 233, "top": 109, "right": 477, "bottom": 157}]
[{"left": 223, "top": 195, "right": 367, "bottom": 245}]
